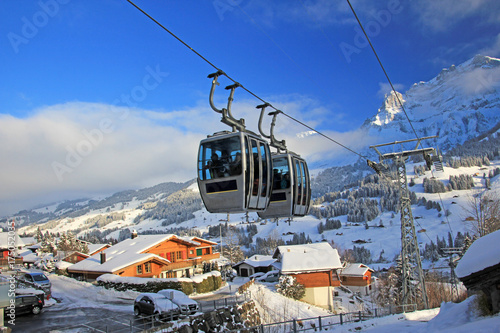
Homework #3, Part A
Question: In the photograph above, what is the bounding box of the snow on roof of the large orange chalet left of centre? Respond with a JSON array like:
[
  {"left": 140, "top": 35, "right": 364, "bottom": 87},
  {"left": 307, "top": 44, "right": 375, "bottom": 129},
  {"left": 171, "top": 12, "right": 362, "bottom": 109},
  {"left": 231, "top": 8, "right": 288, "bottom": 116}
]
[{"left": 70, "top": 234, "right": 175, "bottom": 273}]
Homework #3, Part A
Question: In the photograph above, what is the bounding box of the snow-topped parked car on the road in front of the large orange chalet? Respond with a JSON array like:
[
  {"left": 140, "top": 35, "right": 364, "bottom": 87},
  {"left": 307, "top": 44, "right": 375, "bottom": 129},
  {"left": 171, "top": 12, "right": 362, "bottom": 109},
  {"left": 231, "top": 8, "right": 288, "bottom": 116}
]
[{"left": 134, "top": 293, "right": 181, "bottom": 320}]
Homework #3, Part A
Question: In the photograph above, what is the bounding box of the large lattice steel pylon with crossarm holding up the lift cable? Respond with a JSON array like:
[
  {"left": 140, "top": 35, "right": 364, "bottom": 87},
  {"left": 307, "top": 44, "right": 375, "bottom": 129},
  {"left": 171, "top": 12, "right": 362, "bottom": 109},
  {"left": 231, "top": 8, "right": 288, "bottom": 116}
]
[{"left": 368, "top": 136, "right": 436, "bottom": 309}]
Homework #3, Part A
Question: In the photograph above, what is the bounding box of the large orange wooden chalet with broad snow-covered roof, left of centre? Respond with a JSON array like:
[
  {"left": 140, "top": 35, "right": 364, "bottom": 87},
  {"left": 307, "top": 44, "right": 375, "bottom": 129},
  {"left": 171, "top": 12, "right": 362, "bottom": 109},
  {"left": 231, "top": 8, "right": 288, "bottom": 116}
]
[{"left": 68, "top": 234, "right": 220, "bottom": 280}]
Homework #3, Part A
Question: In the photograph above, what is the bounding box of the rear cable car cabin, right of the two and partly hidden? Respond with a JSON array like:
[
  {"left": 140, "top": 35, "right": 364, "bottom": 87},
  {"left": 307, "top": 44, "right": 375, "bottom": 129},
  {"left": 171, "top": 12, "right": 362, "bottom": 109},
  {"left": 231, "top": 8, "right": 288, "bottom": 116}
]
[{"left": 258, "top": 153, "right": 311, "bottom": 218}]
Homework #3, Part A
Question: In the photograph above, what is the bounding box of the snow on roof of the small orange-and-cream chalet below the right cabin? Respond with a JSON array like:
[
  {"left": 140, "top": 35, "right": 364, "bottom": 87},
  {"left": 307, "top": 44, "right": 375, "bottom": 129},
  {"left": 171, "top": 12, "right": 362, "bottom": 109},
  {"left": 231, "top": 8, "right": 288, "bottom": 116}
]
[{"left": 273, "top": 242, "right": 342, "bottom": 274}]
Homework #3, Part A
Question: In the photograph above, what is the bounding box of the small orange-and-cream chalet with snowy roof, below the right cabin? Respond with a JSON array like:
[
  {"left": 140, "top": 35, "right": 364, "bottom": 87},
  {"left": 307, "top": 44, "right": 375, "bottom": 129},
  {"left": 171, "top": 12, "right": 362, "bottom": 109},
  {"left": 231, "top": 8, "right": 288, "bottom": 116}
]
[{"left": 273, "top": 242, "right": 342, "bottom": 309}]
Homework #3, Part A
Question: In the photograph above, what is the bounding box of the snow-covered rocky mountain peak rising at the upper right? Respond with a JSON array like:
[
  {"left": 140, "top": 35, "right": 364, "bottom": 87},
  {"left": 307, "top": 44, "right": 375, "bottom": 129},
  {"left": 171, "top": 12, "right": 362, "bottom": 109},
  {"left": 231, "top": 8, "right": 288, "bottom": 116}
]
[{"left": 362, "top": 55, "right": 500, "bottom": 151}]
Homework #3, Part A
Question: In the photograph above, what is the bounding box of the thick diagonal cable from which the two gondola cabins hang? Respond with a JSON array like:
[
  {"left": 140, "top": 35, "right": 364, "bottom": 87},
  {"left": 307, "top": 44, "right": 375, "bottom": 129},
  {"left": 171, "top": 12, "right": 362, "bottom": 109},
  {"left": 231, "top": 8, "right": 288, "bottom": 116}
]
[{"left": 126, "top": 0, "right": 368, "bottom": 160}]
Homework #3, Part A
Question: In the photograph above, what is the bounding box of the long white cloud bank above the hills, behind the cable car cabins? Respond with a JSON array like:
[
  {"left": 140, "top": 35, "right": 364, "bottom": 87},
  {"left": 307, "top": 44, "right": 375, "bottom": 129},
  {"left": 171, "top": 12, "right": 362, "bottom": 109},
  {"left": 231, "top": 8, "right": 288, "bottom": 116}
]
[{"left": 0, "top": 96, "right": 376, "bottom": 216}]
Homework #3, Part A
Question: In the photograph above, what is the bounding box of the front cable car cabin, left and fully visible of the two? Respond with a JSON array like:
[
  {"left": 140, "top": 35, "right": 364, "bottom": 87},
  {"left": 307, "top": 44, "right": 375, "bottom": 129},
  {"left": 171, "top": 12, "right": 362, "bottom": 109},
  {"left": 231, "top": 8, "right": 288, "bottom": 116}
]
[{"left": 198, "top": 131, "right": 272, "bottom": 213}]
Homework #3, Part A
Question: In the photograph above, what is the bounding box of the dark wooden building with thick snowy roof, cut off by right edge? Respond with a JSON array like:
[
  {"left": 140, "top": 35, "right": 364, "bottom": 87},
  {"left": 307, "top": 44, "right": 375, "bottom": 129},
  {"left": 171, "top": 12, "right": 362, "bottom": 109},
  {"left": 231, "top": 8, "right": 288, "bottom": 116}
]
[{"left": 455, "top": 230, "right": 500, "bottom": 313}]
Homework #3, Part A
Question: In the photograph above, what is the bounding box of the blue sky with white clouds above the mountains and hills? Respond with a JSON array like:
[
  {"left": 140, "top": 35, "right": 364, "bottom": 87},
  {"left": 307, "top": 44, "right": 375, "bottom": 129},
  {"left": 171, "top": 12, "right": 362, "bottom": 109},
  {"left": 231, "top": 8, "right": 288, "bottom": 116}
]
[{"left": 0, "top": 0, "right": 500, "bottom": 216}]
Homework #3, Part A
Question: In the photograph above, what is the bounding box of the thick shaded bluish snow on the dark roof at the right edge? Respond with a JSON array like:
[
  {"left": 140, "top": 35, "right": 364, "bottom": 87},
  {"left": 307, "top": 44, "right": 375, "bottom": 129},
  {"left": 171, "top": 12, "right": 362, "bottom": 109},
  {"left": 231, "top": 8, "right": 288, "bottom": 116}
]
[{"left": 455, "top": 230, "right": 500, "bottom": 278}]
